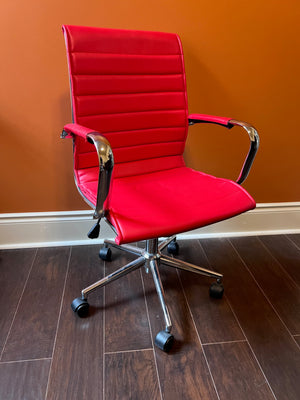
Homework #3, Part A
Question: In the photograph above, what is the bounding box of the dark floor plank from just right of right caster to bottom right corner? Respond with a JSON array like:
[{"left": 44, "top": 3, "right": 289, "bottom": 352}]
[{"left": 202, "top": 239, "right": 300, "bottom": 400}]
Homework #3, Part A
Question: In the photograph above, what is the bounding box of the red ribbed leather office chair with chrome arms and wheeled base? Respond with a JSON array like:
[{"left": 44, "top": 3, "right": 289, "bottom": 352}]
[{"left": 62, "top": 26, "right": 259, "bottom": 351}]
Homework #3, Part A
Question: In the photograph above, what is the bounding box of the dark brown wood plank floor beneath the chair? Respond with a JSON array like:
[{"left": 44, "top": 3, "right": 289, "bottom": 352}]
[{"left": 0, "top": 235, "right": 300, "bottom": 400}]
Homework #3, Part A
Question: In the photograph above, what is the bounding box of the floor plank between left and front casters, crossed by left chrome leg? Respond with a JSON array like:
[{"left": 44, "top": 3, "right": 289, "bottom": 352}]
[{"left": 105, "top": 249, "right": 152, "bottom": 352}]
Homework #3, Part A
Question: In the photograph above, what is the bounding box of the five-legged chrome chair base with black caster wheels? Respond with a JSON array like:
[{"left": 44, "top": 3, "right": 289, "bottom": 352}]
[{"left": 72, "top": 236, "right": 224, "bottom": 351}]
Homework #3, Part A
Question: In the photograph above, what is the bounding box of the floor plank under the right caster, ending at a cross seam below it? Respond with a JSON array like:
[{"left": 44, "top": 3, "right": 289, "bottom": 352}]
[{"left": 176, "top": 240, "right": 245, "bottom": 344}]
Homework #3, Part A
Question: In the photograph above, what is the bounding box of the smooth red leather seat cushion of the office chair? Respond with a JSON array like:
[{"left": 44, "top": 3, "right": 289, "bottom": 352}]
[{"left": 78, "top": 167, "right": 255, "bottom": 244}]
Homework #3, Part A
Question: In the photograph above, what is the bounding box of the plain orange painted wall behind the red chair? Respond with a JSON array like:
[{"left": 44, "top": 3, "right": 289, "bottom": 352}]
[{"left": 0, "top": 0, "right": 300, "bottom": 213}]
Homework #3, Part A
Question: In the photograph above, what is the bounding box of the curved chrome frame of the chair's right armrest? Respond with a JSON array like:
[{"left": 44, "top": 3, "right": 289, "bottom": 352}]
[{"left": 229, "top": 119, "right": 259, "bottom": 185}]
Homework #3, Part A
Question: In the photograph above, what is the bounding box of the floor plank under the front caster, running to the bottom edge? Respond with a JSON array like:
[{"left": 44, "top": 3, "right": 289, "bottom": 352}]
[{"left": 143, "top": 267, "right": 217, "bottom": 400}]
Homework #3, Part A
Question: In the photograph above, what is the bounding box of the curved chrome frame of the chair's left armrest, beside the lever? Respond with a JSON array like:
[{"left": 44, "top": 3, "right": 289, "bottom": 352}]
[{"left": 86, "top": 132, "right": 114, "bottom": 219}]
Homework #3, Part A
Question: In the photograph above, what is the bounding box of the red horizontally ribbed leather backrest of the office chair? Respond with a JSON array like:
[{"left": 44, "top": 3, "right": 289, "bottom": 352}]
[{"left": 63, "top": 25, "right": 188, "bottom": 177}]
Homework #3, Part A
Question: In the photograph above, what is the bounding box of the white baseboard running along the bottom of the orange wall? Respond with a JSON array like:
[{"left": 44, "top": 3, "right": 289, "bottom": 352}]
[{"left": 0, "top": 202, "right": 300, "bottom": 249}]
